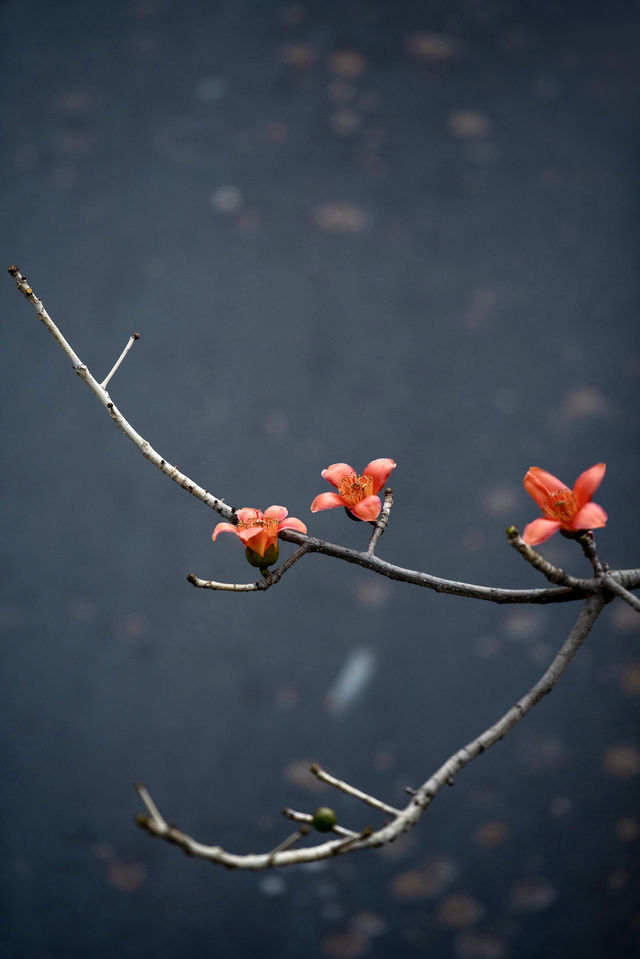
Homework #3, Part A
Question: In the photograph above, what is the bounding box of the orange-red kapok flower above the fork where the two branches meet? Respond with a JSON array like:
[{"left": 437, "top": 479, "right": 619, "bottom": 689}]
[{"left": 522, "top": 463, "right": 607, "bottom": 546}]
